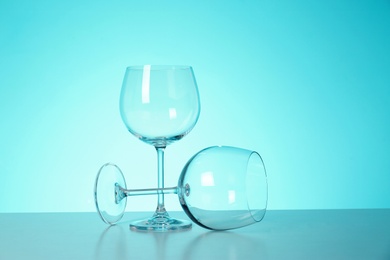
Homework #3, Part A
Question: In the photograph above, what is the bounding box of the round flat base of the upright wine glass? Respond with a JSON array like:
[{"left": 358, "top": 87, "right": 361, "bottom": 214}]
[{"left": 130, "top": 216, "right": 192, "bottom": 232}]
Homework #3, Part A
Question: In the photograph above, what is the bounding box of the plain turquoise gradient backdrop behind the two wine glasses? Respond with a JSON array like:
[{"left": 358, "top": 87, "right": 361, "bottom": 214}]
[{"left": 0, "top": 0, "right": 390, "bottom": 212}]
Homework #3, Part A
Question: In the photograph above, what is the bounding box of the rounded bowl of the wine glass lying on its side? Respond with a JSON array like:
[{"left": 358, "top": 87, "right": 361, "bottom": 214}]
[{"left": 178, "top": 146, "right": 268, "bottom": 230}]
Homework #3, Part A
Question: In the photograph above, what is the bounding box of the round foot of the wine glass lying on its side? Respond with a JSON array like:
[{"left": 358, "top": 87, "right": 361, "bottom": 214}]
[{"left": 95, "top": 163, "right": 127, "bottom": 225}]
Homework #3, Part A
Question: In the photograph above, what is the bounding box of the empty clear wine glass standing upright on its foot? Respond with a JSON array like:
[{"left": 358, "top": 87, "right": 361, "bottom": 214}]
[{"left": 120, "top": 65, "right": 200, "bottom": 231}]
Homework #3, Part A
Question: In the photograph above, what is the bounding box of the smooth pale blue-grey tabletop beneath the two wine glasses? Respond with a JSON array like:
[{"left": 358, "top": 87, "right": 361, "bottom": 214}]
[{"left": 0, "top": 209, "right": 390, "bottom": 260}]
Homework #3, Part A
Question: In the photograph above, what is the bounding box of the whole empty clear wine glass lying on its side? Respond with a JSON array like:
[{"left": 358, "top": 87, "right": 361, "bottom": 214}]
[{"left": 95, "top": 146, "right": 268, "bottom": 231}]
